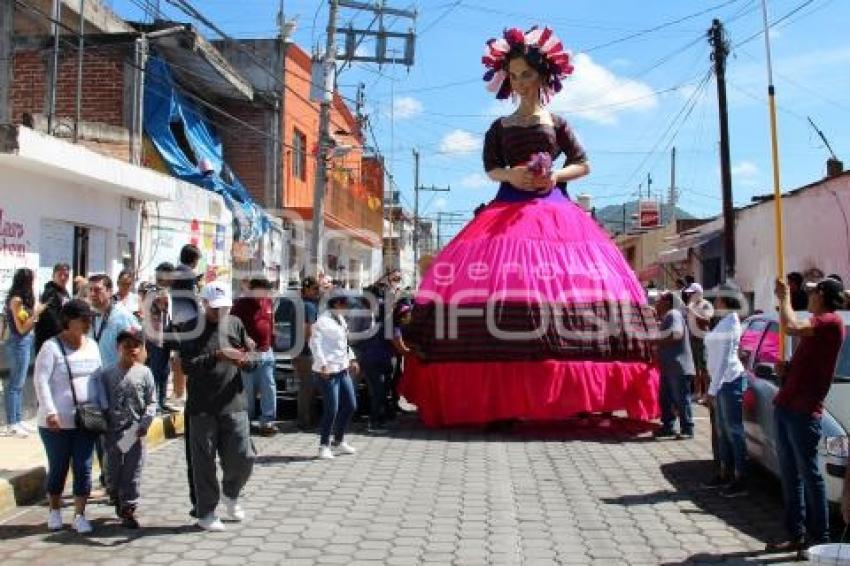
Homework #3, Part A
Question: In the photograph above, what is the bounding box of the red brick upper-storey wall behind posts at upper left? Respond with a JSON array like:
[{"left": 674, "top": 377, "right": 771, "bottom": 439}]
[{"left": 10, "top": 45, "right": 128, "bottom": 126}]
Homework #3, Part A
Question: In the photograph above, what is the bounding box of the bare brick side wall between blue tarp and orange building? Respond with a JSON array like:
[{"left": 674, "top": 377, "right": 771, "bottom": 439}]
[{"left": 216, "top": 102, "right": 272, "bottom": 206}]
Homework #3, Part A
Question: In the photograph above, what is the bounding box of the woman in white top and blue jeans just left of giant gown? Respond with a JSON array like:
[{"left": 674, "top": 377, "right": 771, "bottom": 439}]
[{"left": 310, "top": 293, "right": 360, "bottom": 459}]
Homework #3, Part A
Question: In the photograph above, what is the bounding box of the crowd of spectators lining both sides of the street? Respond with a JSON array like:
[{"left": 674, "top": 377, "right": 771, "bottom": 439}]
[{"left": 3, "top": 253, "right": 850, "bottom": 551}]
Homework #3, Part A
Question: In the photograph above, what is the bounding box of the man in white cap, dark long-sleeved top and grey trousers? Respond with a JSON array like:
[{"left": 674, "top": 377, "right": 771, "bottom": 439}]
[{"left": 180, "top": 281, "right": 256, "bottom": 531}]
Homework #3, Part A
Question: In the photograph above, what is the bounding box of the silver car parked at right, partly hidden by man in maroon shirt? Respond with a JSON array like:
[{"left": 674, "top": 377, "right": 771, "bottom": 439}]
[{"left": 740, "top": 311, "right": 850, "bottom": 504}]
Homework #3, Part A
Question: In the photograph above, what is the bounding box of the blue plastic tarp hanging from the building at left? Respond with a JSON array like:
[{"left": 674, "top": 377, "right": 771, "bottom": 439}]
[{"left": 144, "top": 57, "right": 270, "bottom": 243}]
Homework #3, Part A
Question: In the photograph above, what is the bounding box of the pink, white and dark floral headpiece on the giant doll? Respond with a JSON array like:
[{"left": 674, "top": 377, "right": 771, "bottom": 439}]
[{"left": 481, "top": 26, "right": 573, "bottom": 102}]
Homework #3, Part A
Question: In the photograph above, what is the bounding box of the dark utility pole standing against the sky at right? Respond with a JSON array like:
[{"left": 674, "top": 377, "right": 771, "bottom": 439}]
[{"left": 708, "top": 19, "right": 735, "bottom": 279}]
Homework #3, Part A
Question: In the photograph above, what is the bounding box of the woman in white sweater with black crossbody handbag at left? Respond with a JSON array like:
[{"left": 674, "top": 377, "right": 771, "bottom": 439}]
[{"left": 34, "top": 299, "right": 106, "bottom": 534}]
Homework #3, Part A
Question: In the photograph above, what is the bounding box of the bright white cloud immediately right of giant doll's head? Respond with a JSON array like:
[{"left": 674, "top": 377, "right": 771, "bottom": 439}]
[{"left": 550, "top": 53, "right": 658, "bottom": 125}]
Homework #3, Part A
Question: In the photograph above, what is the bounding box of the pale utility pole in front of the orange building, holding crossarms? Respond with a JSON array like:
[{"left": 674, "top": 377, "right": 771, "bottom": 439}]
[{"left": 310, "top": 0, "right": 339, "bottom": 273}]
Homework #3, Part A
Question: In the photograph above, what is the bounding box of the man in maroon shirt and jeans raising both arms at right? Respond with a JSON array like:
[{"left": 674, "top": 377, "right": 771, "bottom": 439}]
[{"left": 767, "top": 278, "right": 844, "bottom": 552}]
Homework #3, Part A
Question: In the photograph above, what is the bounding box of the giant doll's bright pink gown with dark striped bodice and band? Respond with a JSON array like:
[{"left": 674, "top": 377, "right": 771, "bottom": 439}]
[{"left": 400, "top": 116, "right": 658, "bottom": 426}]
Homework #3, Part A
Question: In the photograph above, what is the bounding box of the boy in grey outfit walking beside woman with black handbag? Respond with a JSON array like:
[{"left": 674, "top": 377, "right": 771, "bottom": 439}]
[{"left": 98, "top": 329, "right": 157, "bottom": 529}]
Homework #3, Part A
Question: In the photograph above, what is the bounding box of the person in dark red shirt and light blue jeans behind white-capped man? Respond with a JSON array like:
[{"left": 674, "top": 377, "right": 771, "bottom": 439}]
[{"left": 230, "top": 277, "right": 277, "bottom": 436}]
